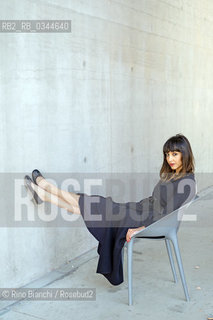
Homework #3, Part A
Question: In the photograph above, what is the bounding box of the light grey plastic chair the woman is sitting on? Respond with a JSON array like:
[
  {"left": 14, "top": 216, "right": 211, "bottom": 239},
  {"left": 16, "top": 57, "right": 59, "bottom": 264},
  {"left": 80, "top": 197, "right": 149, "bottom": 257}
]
[{"left": 122, "top": 195, "right": 199, "bottom": 305}]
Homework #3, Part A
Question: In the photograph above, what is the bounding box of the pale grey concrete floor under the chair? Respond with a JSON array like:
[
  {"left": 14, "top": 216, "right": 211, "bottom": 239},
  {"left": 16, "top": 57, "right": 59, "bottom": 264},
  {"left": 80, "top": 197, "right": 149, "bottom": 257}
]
[{"left": 0, "top": 198, "right": 213, "bottom": 320}]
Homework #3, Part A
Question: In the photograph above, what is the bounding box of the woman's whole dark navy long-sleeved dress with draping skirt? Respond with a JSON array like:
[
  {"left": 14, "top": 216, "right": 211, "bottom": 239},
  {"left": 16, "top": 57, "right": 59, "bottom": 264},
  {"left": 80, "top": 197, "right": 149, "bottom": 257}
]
[{"left": 78, "top": 173, "right": 196, "bottom": 285}]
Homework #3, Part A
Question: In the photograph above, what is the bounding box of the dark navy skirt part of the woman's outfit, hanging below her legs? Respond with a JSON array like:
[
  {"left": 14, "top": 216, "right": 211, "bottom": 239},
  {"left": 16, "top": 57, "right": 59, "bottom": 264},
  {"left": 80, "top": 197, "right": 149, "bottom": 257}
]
[{"left": 78, "top": 193, "right": 152, "bottom": 285}]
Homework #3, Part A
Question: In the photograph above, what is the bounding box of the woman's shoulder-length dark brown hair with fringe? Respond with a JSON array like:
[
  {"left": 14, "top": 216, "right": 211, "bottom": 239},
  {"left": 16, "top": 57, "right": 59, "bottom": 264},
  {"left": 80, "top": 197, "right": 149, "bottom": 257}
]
[{"left": 160, "top": 133, "right": 195, "bottom": 181}]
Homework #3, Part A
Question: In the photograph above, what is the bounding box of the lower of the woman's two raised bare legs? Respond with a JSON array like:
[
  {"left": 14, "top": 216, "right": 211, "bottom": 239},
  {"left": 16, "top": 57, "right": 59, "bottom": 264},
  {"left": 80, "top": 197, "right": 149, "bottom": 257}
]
[{"left": 31, "top": 178, "right": 81, "bottom": 214}]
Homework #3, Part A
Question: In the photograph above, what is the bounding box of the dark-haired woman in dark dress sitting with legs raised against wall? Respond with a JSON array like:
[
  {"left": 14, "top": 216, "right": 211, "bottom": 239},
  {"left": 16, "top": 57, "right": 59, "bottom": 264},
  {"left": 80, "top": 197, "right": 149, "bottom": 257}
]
[{"left": 25, "top": 134, "right": 196, "bottom": 285}]
